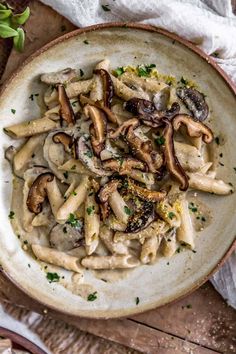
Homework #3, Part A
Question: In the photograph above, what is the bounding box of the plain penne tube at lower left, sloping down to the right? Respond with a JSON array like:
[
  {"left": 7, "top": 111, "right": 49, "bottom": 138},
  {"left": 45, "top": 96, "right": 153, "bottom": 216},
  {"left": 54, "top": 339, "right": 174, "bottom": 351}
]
[{"left": 32, "top": 244, "right": 83, "bottom": 273}]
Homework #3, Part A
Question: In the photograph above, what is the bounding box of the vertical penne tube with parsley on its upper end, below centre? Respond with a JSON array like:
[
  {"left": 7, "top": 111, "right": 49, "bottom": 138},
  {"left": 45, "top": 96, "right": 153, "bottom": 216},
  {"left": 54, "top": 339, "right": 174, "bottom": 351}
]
[{"left": 84, "top": 191, "right": 100, "bottom": 255}]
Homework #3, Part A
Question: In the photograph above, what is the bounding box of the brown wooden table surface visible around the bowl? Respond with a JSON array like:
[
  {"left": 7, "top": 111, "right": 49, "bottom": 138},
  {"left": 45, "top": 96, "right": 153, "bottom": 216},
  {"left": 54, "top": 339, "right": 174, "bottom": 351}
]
[{"left": 0, "top": 0, "right": 236, "bottom": 354}]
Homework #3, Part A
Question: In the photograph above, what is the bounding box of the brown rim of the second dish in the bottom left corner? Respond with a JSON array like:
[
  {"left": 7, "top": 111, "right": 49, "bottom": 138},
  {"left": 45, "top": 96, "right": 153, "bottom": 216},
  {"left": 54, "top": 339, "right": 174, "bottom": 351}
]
[{"left": 0, "top": 327, "right": 46, "bottom": 354}]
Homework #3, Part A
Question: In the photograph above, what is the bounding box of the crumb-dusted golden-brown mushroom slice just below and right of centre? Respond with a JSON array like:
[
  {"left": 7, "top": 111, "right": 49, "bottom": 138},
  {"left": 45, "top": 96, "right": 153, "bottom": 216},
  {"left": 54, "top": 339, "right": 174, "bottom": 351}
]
[{"left": 127, "top": 179, "right": 167, "bottom": 203}]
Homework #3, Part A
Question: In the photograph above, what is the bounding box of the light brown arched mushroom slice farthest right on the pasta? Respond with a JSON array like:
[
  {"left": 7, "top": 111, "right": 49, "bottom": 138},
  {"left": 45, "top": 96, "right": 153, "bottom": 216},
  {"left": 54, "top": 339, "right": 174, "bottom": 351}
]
[{"left": 173, "top": 114, "right": 214, "bottom": 144}]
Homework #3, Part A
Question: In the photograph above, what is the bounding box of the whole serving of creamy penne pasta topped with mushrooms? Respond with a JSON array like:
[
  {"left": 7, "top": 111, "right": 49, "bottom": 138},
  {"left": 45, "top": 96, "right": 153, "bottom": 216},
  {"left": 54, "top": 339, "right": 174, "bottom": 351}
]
[{"left": 5, "top": 59, "right": 233, "bottom": 279}]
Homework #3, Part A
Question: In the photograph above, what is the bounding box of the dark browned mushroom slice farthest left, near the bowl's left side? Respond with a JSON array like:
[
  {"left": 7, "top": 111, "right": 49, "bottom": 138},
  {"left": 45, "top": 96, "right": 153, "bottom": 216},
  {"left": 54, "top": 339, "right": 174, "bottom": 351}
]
[{"left": 26, "top": 172, "right": 54, "bottom": 214}]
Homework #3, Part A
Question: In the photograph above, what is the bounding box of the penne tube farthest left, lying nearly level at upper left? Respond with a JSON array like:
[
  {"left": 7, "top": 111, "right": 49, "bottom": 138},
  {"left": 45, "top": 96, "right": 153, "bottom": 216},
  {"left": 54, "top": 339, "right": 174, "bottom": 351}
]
[{"left": 4, "top": 117, "right": 60, "bottom": 139}]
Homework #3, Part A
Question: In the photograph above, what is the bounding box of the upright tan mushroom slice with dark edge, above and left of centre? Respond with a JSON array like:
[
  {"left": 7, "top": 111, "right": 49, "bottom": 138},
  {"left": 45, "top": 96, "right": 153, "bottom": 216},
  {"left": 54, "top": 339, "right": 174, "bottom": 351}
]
[{"left": 84, "top": 105, "right": 106, "bottom": 156}]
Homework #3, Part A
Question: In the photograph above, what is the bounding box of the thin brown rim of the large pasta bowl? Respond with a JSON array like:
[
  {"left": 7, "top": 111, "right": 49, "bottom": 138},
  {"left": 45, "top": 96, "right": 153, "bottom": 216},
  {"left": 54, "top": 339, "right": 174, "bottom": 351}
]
[{"left": 0, "top": 22, "right": 236, "bottom": 319}]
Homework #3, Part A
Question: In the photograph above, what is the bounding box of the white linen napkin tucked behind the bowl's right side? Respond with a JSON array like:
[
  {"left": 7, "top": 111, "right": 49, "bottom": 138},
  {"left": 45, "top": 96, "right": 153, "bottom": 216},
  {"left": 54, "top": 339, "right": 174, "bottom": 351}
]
[{"left": 41, "top": 0, "right": 236, "bottom": 308}]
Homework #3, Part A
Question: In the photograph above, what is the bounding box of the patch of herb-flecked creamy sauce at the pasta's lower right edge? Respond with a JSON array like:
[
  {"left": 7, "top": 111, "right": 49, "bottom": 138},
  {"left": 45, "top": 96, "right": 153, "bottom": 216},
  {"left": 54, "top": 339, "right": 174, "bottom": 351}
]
[{"left": 187, "top": 192, "right": 212, "bottom": 231}]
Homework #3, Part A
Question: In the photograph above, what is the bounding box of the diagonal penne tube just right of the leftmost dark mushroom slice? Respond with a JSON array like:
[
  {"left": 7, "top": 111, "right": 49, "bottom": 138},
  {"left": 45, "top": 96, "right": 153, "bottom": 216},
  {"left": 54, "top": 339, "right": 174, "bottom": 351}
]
[{"left": 56, "top": 176, "right": 88, "bottom": 221}]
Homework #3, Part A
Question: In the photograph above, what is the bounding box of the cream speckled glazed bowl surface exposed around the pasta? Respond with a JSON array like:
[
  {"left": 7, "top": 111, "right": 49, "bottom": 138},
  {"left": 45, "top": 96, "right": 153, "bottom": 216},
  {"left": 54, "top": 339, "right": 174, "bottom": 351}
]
[{"left": 0, "top": 23, "right": 236, "bottom": 318}]
